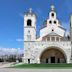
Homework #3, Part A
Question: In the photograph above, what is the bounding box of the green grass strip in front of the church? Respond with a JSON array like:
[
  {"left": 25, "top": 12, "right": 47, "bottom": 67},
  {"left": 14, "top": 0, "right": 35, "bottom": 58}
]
[{"left": 12, "top": 64, "right": 72, "bottom": 68}]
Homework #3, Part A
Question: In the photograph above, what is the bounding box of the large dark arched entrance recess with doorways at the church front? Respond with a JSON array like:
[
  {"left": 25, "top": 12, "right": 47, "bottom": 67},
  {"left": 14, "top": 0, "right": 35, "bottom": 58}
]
[{"left": 40, "top": 48, "right": 66, "bottom": 63}]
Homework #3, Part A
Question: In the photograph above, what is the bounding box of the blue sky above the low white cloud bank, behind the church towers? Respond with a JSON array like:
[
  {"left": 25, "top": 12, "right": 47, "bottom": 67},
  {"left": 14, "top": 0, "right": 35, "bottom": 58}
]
[{"left": 0, "top": 0, "right": 72, "bottom": 48}]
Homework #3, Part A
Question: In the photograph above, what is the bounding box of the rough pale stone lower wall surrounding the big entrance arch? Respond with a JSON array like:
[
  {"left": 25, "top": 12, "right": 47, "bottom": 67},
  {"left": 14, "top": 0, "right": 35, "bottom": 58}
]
[{"left": 24, "top": 41, "right": 71, "bottom": 63}]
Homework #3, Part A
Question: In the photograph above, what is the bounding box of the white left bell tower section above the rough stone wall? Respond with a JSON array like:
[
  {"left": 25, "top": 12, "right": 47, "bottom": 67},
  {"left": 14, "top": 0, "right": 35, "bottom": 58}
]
[{"left": 24, "top": 8, "right": 36, "bottom": 41}]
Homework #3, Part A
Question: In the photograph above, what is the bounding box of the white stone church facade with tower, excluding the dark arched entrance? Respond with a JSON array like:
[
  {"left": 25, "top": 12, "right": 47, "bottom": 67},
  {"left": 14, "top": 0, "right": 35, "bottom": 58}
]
[{"left": 23, "top": 6, "right": 71, "bottom": 63}]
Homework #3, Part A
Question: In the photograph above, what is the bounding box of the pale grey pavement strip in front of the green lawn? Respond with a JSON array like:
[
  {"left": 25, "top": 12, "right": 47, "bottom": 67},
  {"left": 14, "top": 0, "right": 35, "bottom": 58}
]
[{"left": 0, "top": 68, "right": 72, "bottom": 72}]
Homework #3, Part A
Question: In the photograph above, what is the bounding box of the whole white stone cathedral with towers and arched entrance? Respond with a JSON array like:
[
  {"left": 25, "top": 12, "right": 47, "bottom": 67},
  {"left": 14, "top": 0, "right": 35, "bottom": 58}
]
[{"left": 23, "top": 5, "right": 72, "bottom": 64}]
